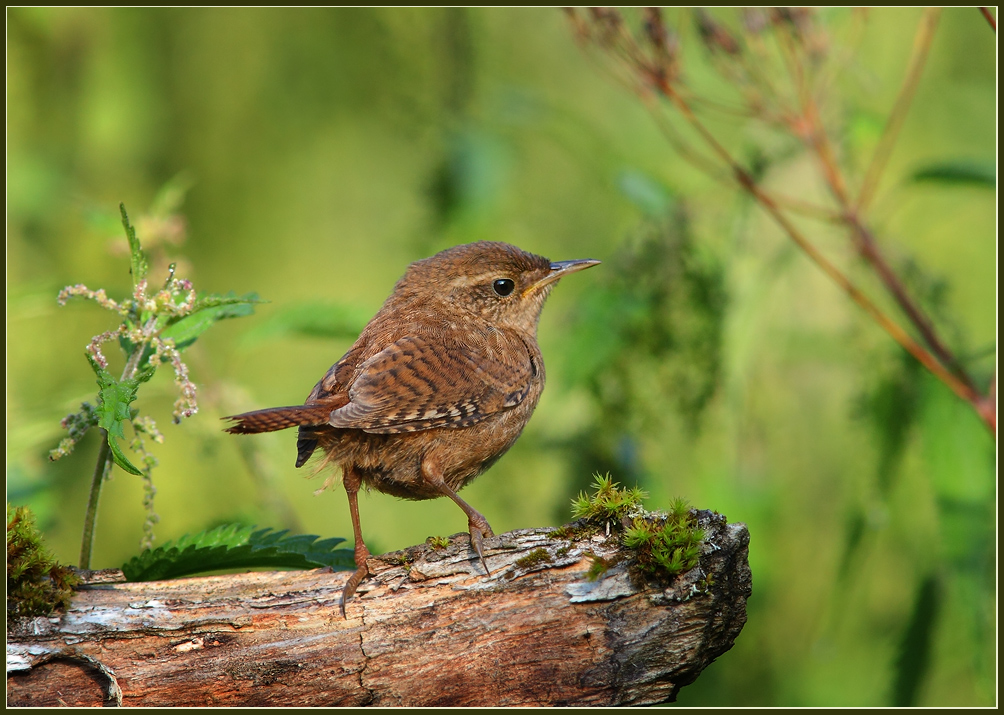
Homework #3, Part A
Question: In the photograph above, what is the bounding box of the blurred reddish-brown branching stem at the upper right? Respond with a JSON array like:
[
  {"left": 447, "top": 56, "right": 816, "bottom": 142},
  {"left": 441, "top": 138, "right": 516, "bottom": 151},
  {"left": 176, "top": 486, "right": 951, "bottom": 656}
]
[{"left": 568, "top": 8, "right": 997, "bottom": 435}]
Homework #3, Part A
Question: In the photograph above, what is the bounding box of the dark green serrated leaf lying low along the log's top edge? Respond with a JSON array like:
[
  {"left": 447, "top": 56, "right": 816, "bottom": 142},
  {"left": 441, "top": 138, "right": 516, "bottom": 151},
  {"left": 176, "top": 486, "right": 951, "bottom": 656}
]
[{"left": 122, "top": 524, "right": 355, "bottom": 581}]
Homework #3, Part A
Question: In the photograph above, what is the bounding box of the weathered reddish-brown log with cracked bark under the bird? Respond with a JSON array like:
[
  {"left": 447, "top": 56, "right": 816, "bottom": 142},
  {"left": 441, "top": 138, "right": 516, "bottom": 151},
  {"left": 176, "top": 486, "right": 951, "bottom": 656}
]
[{"left": 7, "top": 511, "right": 751, "bottom": 706}]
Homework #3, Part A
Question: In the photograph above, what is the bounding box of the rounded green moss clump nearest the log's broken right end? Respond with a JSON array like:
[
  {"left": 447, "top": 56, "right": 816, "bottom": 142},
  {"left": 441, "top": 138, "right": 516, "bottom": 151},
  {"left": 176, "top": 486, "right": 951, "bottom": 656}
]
[{"left": 621, "top": 499, "right": 704, "bottom": 577}]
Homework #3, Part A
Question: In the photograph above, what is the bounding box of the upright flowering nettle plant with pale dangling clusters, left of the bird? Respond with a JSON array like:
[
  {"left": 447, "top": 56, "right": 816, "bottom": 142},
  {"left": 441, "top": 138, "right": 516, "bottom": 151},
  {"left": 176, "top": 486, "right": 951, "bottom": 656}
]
[{"left": 49, "top": 205, "right": 260, "bottom": 568}]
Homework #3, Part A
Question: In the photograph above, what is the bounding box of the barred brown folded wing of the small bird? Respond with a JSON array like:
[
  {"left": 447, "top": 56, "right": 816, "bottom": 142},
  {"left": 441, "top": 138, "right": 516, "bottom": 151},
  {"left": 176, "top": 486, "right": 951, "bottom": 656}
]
[{"left": 329, "top": 336, "right": 537, "bottom": 434}]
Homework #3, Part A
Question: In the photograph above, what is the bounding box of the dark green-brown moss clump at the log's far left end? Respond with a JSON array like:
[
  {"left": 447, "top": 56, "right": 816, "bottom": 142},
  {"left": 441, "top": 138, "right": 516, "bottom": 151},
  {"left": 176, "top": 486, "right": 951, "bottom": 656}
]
[{"left": 7, "top": 504, "right": 80, "bottom": 623}]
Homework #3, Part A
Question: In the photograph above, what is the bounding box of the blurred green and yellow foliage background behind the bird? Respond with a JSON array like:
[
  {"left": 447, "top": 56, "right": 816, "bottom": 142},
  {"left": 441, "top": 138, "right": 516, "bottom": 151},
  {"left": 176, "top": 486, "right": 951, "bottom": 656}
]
[{"left": 7, "top": 8, "right": 997, "bottom": 706}]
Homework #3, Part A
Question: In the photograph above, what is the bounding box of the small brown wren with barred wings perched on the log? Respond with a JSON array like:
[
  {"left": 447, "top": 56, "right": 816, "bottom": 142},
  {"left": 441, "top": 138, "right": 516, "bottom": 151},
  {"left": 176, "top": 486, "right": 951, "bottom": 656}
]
[{"left": 225, "top": 241, "right": 599, "bottom": 616}]
